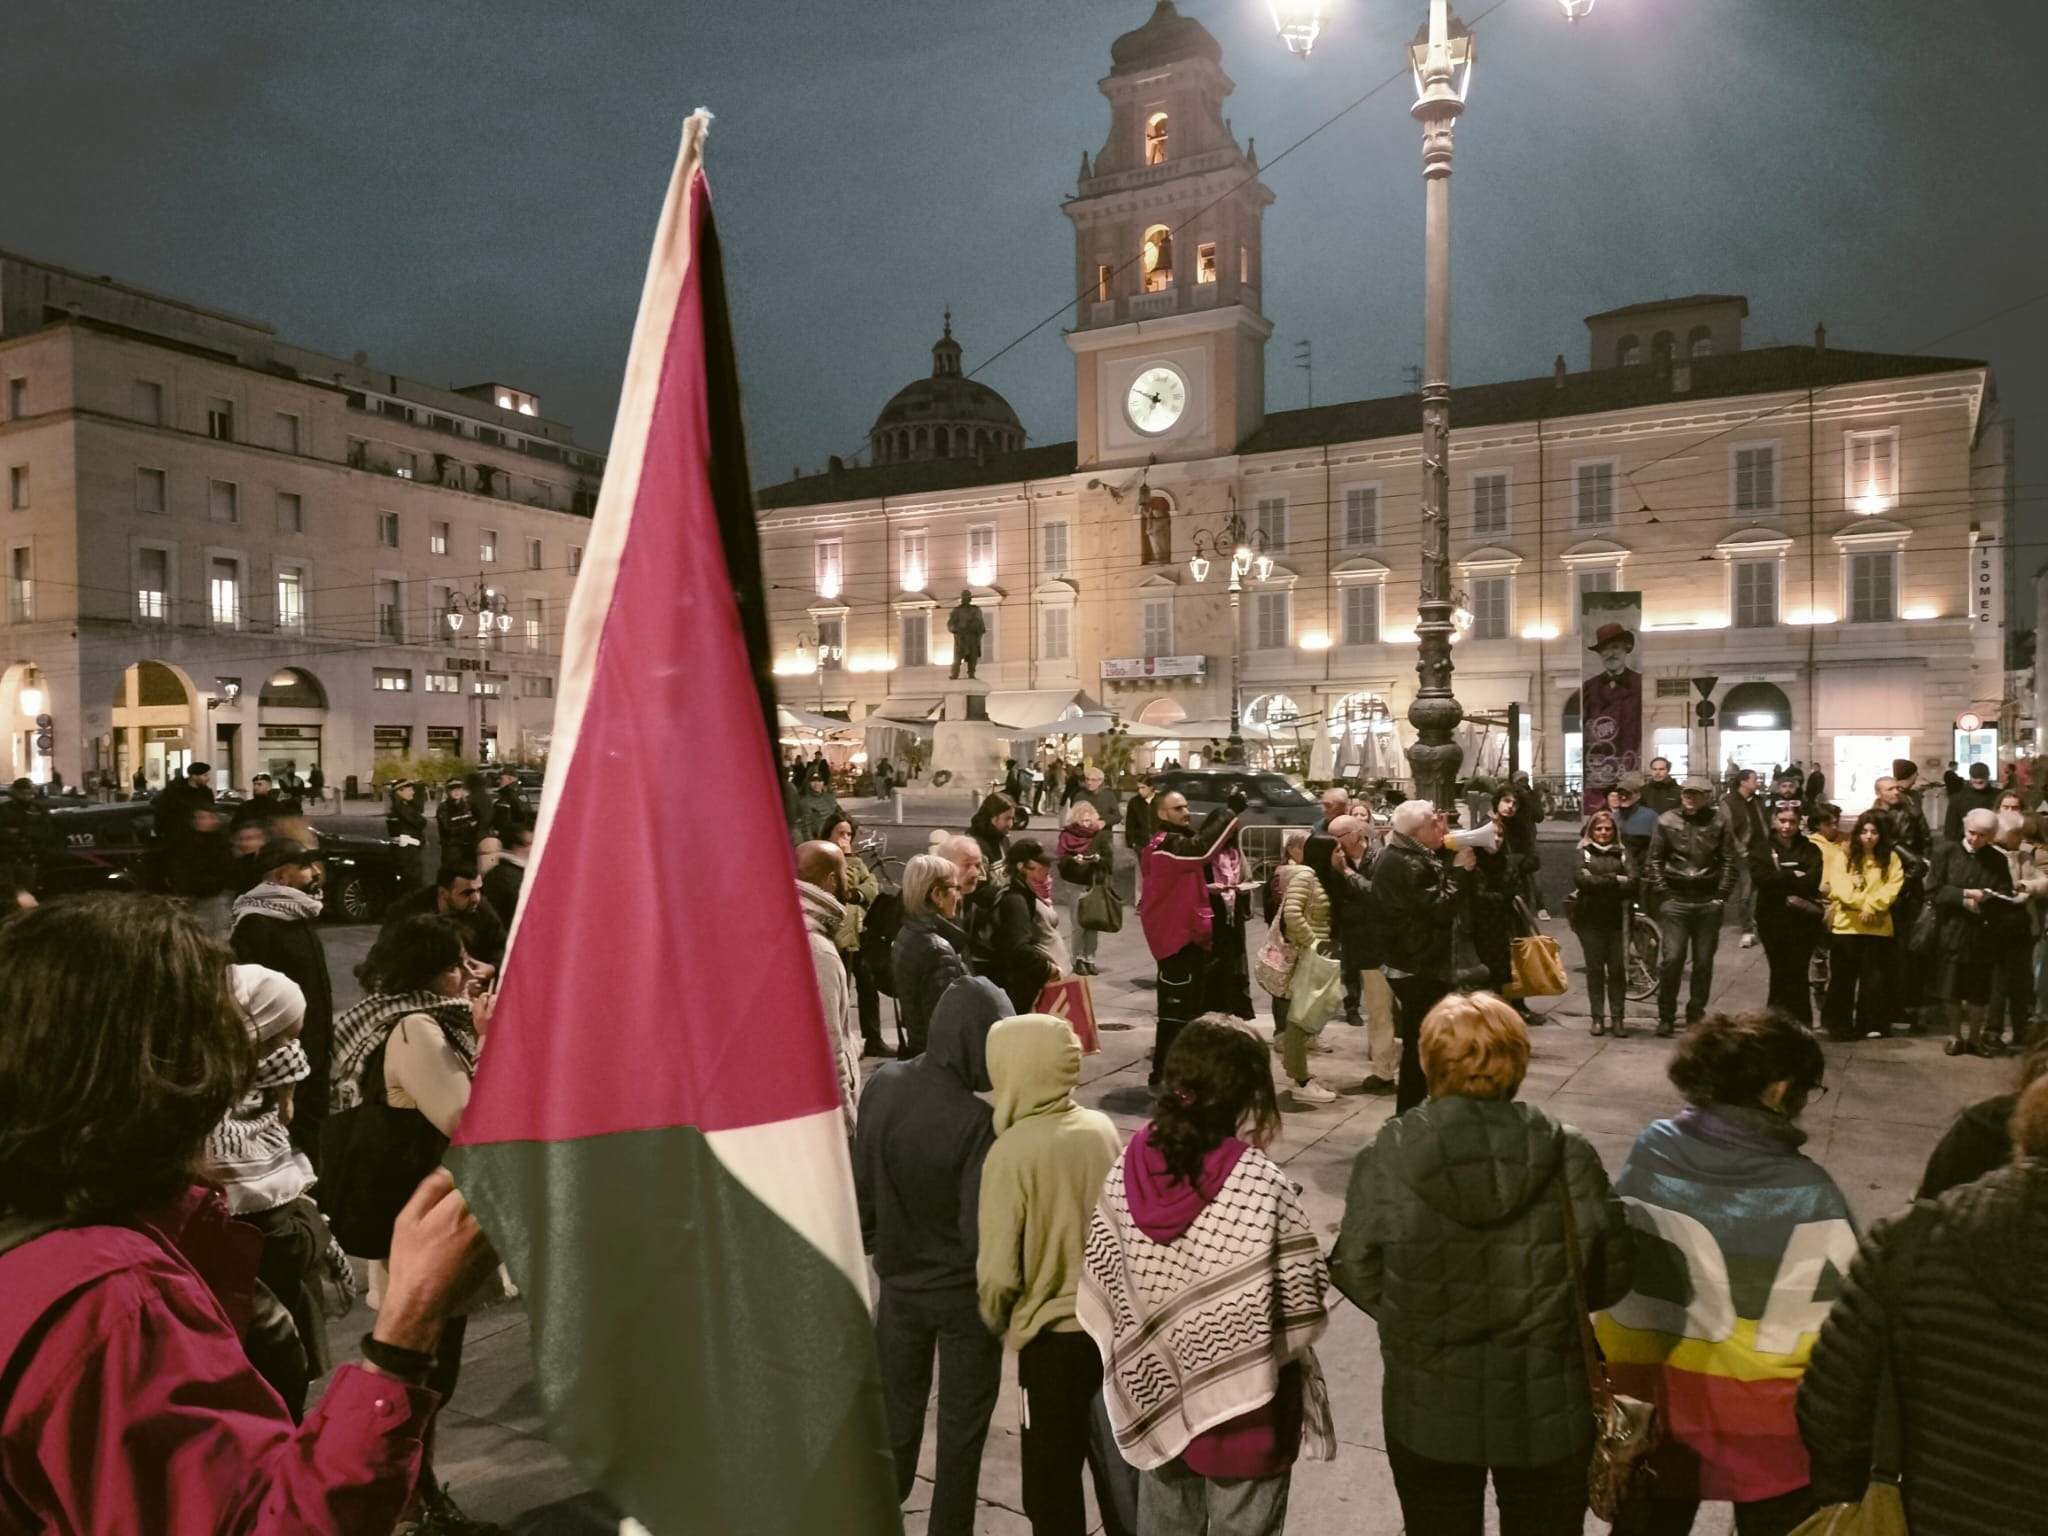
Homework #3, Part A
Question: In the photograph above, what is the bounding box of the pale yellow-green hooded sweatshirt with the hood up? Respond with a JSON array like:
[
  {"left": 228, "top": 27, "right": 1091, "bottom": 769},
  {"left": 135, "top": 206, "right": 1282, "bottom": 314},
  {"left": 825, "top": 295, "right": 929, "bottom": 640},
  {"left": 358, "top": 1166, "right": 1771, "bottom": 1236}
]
[{"left": 975, "top": 1014, "right": 1116, "bottom": 1350}]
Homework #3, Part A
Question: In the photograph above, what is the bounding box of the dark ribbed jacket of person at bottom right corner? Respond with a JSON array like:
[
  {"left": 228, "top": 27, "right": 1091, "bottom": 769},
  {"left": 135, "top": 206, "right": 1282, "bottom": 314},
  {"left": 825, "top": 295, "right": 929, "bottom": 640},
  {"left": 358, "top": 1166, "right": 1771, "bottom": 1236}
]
[{"left": 1798, "top": 1157, "right": 2048, "bottom": 1536}]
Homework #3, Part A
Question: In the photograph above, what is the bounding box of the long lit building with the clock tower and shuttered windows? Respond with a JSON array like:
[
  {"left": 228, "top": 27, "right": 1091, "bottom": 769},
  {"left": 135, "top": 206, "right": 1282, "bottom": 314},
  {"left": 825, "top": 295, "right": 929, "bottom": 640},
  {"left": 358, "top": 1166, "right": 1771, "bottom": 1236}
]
[{"left": 758, "top": 4, "right": 2013, "bottom": 799}]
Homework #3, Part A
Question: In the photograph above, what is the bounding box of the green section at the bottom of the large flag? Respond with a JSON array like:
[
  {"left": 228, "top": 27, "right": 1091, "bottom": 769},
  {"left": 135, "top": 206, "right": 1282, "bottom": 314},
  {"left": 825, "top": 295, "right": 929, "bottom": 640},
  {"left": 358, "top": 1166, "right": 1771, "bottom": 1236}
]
[{"left": 449, "top": 1126, "right": 903, "bottom": 1536}]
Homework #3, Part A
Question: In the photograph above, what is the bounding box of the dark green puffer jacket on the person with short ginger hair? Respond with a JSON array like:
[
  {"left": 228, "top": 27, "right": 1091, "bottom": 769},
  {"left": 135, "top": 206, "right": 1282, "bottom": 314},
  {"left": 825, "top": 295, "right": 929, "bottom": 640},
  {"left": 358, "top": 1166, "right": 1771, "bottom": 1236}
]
[{"left": 1329, "top": 1098, "right": 1634, "bottom": 1466}]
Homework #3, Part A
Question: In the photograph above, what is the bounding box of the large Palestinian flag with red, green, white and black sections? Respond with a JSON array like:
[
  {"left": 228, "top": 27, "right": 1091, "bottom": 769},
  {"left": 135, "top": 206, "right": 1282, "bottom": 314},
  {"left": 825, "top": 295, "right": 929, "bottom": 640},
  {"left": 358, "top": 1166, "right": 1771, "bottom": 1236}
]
[{"left": 449, "top": 113, "right": 901, "bottom": 1536}]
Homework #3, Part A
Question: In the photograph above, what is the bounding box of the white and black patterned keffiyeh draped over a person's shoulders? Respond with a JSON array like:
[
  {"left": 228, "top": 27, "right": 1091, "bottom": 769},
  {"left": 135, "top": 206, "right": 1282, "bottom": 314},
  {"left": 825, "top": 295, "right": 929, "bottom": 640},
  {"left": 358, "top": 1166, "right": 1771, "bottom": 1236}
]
[{"left": 1075, "top": 1139, "right": 1337, "bottom": 1470}]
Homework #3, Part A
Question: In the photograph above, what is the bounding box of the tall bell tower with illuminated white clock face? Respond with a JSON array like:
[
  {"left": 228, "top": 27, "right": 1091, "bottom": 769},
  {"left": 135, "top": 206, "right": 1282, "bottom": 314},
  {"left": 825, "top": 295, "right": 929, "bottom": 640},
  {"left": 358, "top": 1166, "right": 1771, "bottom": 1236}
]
[{"left": 1065, "top": 0, "right": 1274, "bottom": 469}]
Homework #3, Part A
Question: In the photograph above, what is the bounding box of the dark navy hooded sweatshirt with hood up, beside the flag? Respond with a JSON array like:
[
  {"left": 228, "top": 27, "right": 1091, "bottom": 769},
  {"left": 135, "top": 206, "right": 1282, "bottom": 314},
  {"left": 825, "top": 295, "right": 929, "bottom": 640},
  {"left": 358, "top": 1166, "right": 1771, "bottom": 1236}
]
[{"left": 854, "top": 977, "right": 1010, "bottom": 1294}]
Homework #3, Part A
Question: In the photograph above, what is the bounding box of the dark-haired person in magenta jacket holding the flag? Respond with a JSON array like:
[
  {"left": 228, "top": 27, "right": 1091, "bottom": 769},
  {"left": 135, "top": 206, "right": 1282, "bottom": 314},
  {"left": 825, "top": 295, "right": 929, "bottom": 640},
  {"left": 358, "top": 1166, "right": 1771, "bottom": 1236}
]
[{"left": 0, "top": 895, "right": 496, "bottom": 1536}]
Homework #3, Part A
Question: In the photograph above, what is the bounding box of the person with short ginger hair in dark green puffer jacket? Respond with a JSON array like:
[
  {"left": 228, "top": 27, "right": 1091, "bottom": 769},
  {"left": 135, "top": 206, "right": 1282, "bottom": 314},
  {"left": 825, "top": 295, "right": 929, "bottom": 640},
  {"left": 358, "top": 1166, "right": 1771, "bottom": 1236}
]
[{"left": 1329, "top": 993, "right": 1634, "bottom": 1536}]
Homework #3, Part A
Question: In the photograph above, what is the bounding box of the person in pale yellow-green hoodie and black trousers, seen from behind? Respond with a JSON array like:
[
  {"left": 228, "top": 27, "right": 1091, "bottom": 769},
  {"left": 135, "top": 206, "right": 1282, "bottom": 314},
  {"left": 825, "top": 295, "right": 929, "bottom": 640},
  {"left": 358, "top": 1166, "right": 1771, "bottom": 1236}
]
[{"left": 975, "top": 1014, "right": 1120, "bottom": 1536}]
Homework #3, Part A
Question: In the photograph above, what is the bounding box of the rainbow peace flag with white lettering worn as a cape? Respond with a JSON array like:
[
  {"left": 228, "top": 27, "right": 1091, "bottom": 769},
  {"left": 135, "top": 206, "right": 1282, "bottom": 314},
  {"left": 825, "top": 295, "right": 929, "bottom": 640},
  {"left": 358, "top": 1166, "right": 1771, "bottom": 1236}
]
[{"left": 1597, "top": 1104, "right": 1855, "bottom": 1503}]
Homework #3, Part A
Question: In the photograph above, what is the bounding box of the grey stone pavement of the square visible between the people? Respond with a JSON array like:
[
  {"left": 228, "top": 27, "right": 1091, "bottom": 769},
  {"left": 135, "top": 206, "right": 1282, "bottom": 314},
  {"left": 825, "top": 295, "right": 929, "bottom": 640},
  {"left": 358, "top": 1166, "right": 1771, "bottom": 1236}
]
[{"left": 315, "top": 901, "right": 2015, "bottom": 1536}]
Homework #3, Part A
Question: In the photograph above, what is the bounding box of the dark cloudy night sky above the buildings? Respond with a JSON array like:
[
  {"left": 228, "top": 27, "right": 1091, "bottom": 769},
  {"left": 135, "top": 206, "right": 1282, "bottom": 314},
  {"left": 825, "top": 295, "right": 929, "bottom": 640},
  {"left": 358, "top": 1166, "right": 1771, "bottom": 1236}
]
[{"left": 0, "top": 0, "right": 2048, "bottom": 589}]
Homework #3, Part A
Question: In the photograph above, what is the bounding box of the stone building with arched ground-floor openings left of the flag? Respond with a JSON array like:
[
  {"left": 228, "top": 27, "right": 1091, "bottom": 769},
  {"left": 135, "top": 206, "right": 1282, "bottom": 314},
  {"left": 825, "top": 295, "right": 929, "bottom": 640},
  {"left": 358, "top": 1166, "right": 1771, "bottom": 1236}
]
[{"left": 0, "top": 252, "right": 602, "bottom": 786}]
